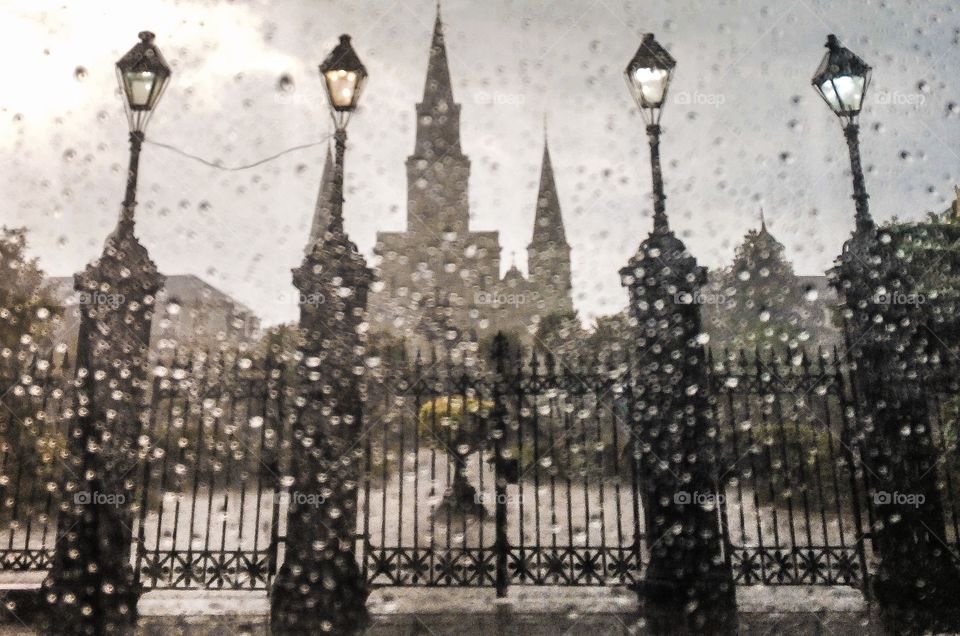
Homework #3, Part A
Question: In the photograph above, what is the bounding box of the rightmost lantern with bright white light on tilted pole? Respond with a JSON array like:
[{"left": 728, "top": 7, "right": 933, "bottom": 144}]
[{"left": 812, "top": 34, "right": 873, "bottom": 232}]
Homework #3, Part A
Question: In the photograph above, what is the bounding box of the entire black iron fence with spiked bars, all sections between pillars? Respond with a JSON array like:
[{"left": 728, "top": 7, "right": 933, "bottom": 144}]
[{"left": 0, "top": 342, "right": 960, "bottom": 590}]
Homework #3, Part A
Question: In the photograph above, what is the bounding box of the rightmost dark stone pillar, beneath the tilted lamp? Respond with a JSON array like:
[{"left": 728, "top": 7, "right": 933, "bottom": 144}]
[{"left": 832, "top": 226, "right": 960, "bottom": 633}]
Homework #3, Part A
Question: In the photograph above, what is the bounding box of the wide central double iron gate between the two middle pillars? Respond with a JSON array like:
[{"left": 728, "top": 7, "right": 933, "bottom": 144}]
[{"left": 359, "top": 346, "right": 643, "bottom": 595}]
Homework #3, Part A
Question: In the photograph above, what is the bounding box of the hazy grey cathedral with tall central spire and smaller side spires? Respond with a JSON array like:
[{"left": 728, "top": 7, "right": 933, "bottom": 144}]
[{"left": 356, "top": 8, "right": 573, "bottom": 347}]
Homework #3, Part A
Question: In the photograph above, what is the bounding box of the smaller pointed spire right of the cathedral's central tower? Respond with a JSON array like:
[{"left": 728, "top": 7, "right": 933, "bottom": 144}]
[{"left": 527, "top": 131, "right": 573, "bottom": 315}]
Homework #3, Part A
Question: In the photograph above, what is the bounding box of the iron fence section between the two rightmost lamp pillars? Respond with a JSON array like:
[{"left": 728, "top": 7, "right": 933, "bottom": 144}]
[{"left": 710, "top": 350, "right": 869, "bottom": 587}]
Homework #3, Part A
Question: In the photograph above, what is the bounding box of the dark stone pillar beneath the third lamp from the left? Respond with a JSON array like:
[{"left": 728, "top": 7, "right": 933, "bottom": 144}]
[{"left": 620, "top": 228, "right": 737, "bottom": 634}]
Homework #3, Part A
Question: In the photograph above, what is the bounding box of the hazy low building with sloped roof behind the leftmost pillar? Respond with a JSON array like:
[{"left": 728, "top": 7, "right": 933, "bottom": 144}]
[{"left": 45, "top": 274, "right": 260, "bottom": 352}]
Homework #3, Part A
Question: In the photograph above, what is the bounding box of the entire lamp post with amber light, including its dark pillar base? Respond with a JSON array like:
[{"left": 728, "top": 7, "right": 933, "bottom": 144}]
[{"left": 270, "top": 35, "right": 373, "bottom": 636}]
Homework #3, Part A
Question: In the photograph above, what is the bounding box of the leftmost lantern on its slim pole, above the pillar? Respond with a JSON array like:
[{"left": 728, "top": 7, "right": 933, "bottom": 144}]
[{"left": 117, "top": 31, "right": 170, "bottom": 223}]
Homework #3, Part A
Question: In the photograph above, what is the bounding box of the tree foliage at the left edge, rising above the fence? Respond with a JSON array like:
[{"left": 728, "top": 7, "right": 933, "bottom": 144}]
[{"left": 0, "top": 226, "right": 60, "bottom": 350}]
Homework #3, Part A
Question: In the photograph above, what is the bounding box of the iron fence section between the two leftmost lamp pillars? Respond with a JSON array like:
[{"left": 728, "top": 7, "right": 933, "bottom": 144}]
[{"left": 134, "top": 349, "right": 290, "bottom": 590}]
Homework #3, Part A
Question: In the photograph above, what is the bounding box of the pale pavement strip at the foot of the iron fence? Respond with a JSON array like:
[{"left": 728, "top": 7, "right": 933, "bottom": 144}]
[{"left": 0, "top": 587, "right": 882, "bottom": 636}]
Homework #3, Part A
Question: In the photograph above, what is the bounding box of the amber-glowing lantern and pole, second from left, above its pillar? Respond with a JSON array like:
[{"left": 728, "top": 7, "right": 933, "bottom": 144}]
[{"left": 320, "top": 34, "right": 367, "bottom": 232}]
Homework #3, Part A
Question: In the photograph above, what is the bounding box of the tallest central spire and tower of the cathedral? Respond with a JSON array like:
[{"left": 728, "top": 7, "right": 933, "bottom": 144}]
[{"left": 407, "top": 6, "right": 470, "bottom": 237}]
